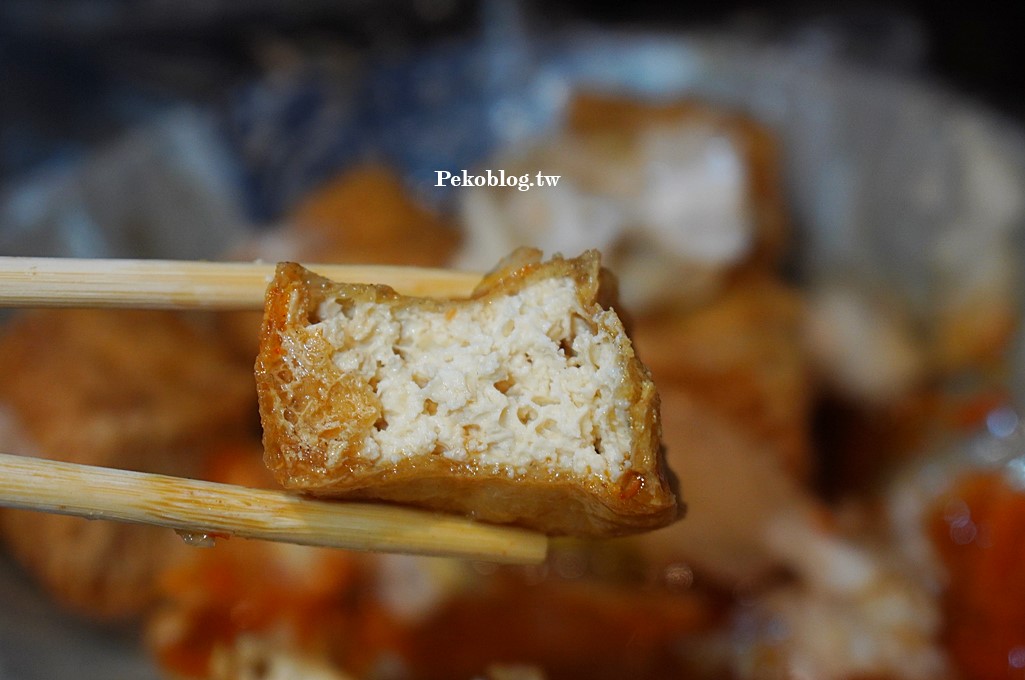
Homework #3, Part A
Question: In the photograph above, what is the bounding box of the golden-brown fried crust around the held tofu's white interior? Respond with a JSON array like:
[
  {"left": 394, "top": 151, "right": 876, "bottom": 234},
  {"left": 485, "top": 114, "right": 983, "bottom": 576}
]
[{"left": 256, "top": 250, "right": 678, "bottom": 535}]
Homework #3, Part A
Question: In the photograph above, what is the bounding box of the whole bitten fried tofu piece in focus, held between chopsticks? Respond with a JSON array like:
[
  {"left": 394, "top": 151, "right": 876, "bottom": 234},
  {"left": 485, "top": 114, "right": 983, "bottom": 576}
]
[{"left": 256, "top": 248, "right": 679, "bottom": 536}]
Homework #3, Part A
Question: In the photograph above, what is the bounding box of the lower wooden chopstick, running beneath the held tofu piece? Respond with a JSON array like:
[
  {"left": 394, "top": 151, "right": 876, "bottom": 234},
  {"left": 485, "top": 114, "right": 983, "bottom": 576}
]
[{"left": 0, "top": 453, "right": 547, "bottom": 564}]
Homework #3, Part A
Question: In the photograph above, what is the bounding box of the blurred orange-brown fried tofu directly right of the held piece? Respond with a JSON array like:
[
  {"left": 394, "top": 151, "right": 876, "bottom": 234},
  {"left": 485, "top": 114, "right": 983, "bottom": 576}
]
[{"left": 632, "top": 275, "right": 815, "bottom": 481}]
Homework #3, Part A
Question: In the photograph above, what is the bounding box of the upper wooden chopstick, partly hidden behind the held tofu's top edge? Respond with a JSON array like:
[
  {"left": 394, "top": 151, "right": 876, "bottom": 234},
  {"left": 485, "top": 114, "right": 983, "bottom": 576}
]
[{"left": 0, "top": 256, "right": 481, "bottom": 310}]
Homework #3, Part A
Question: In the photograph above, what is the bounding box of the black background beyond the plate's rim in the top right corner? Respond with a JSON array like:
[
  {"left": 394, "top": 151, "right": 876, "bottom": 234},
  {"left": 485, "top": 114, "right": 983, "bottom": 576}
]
[{"left": 556, "top": 0, "right": 1025, "bottom": 118}]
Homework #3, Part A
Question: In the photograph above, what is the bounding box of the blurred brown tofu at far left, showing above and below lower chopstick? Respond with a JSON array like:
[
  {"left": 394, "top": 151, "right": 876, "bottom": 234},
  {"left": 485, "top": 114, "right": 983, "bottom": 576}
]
[{"left": 0, "top": 310, "right": 255, "bottom": 619}]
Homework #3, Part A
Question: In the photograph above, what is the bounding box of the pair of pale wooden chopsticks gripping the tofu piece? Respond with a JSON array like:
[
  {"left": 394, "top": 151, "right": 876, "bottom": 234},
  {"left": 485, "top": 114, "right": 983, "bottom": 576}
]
[{"left": 0, "top": 257, "right": 547, "bottom": 564}]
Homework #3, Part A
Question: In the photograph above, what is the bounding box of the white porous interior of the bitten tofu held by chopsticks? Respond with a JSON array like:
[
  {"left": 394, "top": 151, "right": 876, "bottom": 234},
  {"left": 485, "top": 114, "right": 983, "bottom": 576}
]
[{"left": 313, "top": 278, "right": 630, "bottom": 482}]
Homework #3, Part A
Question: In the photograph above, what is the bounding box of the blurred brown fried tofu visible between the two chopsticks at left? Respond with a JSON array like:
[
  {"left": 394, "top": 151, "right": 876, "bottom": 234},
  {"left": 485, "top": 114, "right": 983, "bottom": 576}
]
[{"left": 0, "top": 310, "right": 255, "bottom": 455}]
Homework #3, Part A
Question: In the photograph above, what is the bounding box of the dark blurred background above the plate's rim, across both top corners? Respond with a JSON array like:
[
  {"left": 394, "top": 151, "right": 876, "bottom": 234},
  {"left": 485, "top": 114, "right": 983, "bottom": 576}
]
[{"left": 0, "top": 0, "right": 1025, "bottom": 200}]
